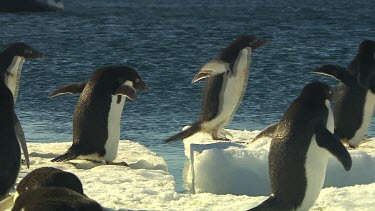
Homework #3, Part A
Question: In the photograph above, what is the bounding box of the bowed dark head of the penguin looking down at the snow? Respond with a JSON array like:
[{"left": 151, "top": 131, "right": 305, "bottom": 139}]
[{"left": 98, "top": 66, "right": 148, "bottom": 90}]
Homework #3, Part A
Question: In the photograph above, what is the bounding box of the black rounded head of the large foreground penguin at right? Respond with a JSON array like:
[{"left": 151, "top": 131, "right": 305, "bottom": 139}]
[{"left": 299, "top": 81, "right": 332, "bottom": 106}]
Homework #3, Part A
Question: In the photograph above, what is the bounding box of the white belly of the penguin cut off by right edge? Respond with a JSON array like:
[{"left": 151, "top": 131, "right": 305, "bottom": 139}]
[{"left": 349, "top": 90, "right": 375, "bottom": 147}]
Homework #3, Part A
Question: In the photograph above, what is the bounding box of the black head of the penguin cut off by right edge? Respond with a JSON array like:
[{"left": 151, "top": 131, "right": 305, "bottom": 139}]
[{"left": 356, "top": 40, "right": 375, "bottom": 93}]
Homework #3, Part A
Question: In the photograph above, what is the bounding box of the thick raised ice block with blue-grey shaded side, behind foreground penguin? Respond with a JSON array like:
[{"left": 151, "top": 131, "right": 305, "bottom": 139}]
[{"left": 184, "top": 131, "right": 375, "bottom": 196}]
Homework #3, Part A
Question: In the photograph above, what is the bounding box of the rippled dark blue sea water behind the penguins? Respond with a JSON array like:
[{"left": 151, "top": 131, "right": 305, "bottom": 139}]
[{"left": 0, "top": 0, "right": 375, "bottom": 190}]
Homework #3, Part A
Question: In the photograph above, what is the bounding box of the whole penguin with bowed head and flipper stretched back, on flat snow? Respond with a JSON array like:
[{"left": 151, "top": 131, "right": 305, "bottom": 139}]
[{"left": 50, "top": 66, "right": 148, "bottom": 165}]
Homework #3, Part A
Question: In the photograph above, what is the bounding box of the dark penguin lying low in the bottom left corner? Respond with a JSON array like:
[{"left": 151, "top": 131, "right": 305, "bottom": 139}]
[{"left": 0, "top": 167, "right": 103, "bottom": 211}]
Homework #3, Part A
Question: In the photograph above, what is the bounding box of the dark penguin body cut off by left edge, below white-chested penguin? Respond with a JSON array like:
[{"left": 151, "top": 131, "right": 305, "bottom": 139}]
[{"left": 0, "top": 81, "right": 21, "bottom": 198}]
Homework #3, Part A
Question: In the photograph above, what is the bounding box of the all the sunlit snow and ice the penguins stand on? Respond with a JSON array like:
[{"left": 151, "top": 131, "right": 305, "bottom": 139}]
[{"left": 4, "top": 130, "right": 375, "bottom": 211}]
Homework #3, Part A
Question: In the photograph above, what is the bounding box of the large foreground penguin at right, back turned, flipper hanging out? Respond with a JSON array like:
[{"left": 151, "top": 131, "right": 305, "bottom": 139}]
[{"left": 250, "top": 81, "right": 352, "bottom": 211}]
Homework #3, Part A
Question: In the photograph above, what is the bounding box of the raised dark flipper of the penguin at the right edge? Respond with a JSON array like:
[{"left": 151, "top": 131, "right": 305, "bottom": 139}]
[{"left": 313, "top": 64, "right": 358, "bottom": 87}]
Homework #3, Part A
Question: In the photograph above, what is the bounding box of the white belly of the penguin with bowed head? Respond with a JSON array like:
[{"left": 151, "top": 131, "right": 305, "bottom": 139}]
[{"left": 104, "top": 95, "right": 126, "bottom": 161}]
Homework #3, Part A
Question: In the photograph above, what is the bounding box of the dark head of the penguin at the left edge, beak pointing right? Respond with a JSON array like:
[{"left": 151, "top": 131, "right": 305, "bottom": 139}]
[{"left": 4, "top": 42, "right": 44, "bottom": 59}]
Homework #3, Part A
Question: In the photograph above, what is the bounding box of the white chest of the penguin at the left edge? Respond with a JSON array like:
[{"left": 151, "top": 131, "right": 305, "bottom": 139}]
[{"left": 5, "top": 56, "right": 25, "bottom": 102}]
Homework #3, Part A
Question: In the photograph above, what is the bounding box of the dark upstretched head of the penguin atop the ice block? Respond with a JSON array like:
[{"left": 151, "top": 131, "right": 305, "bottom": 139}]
[{"left": 219, "top": 35, "right": 266, "bottom": 63}]
